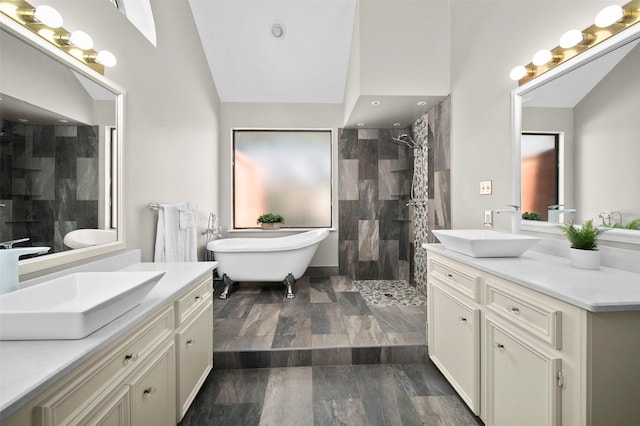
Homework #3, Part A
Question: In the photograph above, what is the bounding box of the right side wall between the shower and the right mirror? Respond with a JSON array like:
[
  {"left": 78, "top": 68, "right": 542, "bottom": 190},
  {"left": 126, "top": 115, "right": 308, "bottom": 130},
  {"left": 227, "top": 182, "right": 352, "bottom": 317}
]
[{"left": 451, "top": 0, "right": 608, "bottom": 229}]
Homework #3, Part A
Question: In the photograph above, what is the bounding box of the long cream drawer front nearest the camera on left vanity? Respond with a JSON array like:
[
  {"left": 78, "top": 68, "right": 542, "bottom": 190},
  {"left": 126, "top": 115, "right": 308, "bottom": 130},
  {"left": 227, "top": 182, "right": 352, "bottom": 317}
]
[{"left": 35, "top": 308, "right": 173, "bottom": 425}]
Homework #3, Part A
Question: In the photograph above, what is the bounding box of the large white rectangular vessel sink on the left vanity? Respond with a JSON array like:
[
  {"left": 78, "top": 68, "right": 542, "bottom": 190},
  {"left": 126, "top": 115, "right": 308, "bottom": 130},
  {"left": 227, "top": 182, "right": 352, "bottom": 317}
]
[{"left": 0, "top": 272, "right": 164, "bottom": 340}]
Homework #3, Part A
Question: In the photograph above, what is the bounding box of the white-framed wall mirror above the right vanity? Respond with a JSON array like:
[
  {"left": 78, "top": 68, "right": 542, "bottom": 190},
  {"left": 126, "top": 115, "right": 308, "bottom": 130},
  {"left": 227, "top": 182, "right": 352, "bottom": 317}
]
[{"left": 512, "top": 21, "right": 640, "bottom": 244}]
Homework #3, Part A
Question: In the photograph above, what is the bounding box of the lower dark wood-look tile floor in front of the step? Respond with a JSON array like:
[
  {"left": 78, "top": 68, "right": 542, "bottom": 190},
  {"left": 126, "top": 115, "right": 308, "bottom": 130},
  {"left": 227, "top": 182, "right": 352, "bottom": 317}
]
[{"left": 180, "top": 362, "right": 482, "bottom": 426}]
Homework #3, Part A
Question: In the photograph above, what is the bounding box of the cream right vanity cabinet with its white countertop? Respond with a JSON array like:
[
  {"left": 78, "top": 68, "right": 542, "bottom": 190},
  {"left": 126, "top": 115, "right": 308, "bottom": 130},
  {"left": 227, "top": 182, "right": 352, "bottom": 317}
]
[{"left": 424, "top": 244, "right": 640, "bottom": 426}]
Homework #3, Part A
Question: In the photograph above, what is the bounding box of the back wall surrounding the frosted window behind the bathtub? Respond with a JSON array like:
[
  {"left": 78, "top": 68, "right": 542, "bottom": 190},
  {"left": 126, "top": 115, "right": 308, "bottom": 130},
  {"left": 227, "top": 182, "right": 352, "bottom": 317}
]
[{"left": 218, "top": 102, "right": 343, "bottom": 266}]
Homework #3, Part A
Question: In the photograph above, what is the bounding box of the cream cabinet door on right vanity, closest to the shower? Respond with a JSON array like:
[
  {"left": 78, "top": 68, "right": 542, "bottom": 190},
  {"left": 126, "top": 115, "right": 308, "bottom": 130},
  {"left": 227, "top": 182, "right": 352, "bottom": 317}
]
[{"left": 429, "top": 282, "right": 480, "bottom": 415}]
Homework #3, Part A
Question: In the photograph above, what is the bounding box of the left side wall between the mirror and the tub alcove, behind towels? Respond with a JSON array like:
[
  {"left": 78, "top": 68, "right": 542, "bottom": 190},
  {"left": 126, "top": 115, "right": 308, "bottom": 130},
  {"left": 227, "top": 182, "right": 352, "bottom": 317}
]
[{"left": 40, "top": 0, "right": 219, "bottom": 261}]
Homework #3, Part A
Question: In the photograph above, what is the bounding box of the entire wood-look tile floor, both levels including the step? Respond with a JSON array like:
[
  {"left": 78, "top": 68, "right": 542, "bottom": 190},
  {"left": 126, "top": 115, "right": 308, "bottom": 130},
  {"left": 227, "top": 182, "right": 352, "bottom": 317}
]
[{"left": 180, "top": 276, "right": 482, "bottom": 426}]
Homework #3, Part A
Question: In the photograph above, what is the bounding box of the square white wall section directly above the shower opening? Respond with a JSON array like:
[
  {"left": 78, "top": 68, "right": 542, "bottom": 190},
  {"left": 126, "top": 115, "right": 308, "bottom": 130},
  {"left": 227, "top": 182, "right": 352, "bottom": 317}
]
[{"left": 358, "top": 0, "right": 450, "bottom": 96}]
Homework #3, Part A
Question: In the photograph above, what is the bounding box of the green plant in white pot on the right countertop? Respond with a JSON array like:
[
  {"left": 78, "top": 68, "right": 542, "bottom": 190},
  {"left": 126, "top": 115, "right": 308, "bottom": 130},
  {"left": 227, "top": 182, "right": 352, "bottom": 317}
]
[{"left": 559, "top": 220, "right": 604, "bottom": 269}]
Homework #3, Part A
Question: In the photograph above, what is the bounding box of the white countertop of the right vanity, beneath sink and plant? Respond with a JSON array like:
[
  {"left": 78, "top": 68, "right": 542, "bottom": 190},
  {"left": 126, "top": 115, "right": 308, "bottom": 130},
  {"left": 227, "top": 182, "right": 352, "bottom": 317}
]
[{"left": 422, "top": 244, "right": 640, "bottom": 312}]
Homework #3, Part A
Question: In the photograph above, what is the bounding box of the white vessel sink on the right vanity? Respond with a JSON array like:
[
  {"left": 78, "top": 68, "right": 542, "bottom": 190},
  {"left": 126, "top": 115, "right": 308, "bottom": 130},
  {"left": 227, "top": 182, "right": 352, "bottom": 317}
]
[{"left": 432, "top": 229, "right": 540, "bottom": 257}]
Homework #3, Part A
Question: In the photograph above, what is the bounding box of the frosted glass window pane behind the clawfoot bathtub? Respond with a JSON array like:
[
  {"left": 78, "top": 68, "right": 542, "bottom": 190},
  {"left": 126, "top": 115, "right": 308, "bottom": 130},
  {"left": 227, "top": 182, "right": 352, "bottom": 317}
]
[{"left": 233, "top": 130, "right": 331, "bottom": 228}]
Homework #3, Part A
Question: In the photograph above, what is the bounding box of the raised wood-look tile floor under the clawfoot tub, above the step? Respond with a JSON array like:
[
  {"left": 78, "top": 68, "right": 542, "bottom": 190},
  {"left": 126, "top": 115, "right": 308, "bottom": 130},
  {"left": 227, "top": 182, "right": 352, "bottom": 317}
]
[{"left": 213, "top": 276, "right": 426, "bottom": 351}]
